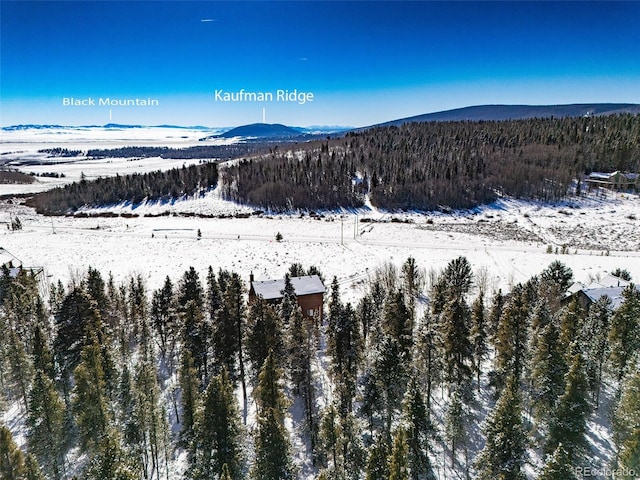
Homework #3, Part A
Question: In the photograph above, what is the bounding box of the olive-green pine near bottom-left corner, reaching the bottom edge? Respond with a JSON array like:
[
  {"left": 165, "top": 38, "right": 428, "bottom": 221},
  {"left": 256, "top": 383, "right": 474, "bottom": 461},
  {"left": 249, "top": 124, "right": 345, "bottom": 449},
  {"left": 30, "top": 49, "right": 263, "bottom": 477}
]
[{"left": 27, "top": 370, "right": 65, "bottom": 480}]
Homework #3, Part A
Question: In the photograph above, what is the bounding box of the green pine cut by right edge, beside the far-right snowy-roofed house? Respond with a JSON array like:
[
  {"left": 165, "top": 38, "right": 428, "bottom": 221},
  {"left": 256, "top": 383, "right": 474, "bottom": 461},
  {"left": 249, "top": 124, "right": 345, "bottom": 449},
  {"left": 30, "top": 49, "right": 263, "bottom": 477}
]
[{"left": 609, "top": 284, "right": 640, "bottom": 381}]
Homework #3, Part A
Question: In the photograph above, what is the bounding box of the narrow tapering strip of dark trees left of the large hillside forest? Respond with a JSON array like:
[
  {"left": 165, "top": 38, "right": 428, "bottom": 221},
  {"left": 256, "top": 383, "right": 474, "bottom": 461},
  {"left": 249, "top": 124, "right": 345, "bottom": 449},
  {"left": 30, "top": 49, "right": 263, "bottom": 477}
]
[{"left": 26, "top": 163, "right": 218, "bottom": 215}]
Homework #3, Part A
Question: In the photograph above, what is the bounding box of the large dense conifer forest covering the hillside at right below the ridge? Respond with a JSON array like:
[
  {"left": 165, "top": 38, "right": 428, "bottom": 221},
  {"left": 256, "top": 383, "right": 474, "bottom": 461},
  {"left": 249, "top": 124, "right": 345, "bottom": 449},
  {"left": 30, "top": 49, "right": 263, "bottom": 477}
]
[{"left": 224, "top": 115, "right": 640, "bottom": 210}]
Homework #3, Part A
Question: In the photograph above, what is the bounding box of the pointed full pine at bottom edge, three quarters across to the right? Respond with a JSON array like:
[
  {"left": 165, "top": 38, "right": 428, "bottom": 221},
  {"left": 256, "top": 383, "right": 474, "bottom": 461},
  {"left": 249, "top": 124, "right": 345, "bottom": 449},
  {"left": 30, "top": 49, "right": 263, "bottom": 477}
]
[{"left": 475, "top": 377, "right": 527, "bottom": 480}]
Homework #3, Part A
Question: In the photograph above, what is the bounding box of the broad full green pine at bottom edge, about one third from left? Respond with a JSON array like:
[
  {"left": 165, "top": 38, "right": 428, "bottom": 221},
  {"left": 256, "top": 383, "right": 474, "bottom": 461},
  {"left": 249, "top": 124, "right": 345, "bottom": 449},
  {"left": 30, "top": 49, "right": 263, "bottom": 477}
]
[{"left": 192, "top": 369, "right": 243, "bottom": 480}]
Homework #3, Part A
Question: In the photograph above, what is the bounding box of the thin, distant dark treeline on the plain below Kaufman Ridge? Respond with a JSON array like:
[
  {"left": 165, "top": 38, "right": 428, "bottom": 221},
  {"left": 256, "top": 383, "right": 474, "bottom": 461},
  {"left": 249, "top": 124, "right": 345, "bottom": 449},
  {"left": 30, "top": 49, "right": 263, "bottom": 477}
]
[{"left": 87, "top": 143, "right": 265, "bottom": 159}]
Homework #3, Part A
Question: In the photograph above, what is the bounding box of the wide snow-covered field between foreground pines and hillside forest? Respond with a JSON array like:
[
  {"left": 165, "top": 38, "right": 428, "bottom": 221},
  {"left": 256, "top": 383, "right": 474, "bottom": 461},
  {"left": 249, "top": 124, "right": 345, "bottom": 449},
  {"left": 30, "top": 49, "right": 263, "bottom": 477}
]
[{"left": 0, "top": 192, "right": 640, "bottom": 298}]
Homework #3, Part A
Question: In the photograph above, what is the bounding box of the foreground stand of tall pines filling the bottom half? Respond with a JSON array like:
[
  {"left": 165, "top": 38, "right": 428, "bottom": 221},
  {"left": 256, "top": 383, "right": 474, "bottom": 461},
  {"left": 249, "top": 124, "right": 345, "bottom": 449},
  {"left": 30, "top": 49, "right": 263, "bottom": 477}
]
[{"left": 0, "top": 257, "right": 640, "bottom": 480}]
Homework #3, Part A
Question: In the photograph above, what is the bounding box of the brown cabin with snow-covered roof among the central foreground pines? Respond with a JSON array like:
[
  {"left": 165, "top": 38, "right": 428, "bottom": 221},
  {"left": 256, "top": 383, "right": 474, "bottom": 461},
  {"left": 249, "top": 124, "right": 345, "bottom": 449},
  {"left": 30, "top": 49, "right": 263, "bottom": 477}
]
[{"left": 249, "top": 274, "right": 325, "bottom": 320}]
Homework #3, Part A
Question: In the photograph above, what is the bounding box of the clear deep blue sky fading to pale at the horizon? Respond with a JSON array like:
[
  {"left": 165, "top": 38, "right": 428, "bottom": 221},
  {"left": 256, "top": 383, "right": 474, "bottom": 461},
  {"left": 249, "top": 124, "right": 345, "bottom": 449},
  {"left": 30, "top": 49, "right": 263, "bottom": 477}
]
[{"left": 0, "top": 1, "right": 640, "bottom": 126}]
